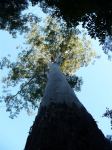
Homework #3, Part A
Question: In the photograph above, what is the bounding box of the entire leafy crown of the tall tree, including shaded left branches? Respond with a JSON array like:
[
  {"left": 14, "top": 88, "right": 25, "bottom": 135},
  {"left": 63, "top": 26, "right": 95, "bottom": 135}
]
[{"left": 1, "top": 17, "right": 96, "bottom": 118}]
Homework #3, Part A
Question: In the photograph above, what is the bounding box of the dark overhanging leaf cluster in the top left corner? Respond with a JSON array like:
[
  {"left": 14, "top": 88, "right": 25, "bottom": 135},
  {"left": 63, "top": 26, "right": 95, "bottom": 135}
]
[{"left": 0, "top": 0, "right": 39, "bottom": 36}]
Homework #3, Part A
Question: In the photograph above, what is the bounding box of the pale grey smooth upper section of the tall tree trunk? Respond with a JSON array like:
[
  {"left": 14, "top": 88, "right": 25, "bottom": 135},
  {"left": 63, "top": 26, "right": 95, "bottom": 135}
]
[{"left": 40, "top": 63, "right": 83, "bottom": 108}]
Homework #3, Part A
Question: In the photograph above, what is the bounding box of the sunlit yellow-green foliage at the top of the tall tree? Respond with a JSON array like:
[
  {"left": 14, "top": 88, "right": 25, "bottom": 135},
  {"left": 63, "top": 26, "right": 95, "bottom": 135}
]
[{"left": 27, "top": 17, "right": 96, "bottom": 74}]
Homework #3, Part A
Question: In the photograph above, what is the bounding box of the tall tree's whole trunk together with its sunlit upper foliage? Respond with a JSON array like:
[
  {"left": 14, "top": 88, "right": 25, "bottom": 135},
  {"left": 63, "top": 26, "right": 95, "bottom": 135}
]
[{"left": 25, "top": 19, "right": 112, "bottom": 150}]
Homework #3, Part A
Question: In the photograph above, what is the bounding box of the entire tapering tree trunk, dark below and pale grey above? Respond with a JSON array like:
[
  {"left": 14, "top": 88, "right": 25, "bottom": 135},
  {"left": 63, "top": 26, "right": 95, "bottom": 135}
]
[{"left": 25, "top": 63, "right": 111, "bottom": 150}]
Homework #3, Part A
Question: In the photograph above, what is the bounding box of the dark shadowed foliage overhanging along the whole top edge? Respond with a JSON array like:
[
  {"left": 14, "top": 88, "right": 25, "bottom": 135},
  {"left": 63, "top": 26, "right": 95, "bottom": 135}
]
[{"left": 0, "top": 0, "right": 112, "bottom": 46}]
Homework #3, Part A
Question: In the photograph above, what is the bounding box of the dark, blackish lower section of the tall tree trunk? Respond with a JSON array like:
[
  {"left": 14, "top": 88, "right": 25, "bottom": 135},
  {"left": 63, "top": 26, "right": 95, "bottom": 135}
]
[{"left": 25, "top": 103, "right": 111, "bottom": 150}]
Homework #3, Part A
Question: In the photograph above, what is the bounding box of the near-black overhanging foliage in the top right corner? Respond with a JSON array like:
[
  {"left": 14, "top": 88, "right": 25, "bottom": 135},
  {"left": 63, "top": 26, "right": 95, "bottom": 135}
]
[{"left": 35, "top": 0, "right": 112, "bottom": 43}]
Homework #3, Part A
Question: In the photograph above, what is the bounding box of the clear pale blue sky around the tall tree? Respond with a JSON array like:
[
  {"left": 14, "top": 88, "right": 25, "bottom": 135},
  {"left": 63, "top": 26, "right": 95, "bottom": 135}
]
[{"left": 0, "top": 5, "right": 112, "bottom": 150}]
